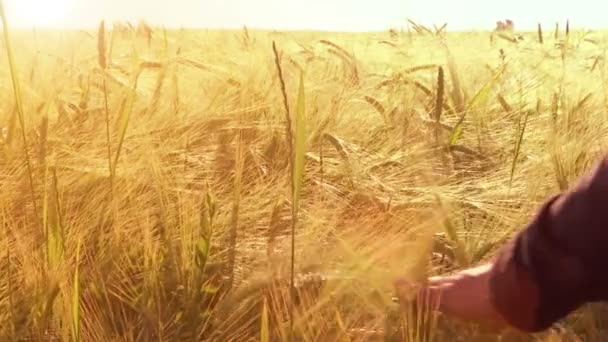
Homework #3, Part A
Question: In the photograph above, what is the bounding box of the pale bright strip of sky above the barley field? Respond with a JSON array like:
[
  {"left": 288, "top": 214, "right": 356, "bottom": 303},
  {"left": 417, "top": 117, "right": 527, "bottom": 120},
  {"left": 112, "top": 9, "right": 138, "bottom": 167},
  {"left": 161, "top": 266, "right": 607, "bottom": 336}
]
[{"left": 2, "top": 0, "right": 608, "bottom": 31}]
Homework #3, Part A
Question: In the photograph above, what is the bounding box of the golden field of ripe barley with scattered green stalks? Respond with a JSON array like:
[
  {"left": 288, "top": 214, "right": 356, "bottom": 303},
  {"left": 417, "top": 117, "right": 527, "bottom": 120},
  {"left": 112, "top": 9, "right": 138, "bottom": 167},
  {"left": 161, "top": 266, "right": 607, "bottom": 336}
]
[{"left": 0, "top": 16, "right": 608, "bottom": 342}]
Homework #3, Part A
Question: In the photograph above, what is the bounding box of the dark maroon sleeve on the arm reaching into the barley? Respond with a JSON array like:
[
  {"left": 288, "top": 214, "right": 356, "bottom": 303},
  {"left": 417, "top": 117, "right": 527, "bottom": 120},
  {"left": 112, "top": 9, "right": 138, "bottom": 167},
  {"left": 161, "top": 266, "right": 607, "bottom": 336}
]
[{"left": 490, "top": 158, "right": 608, "bottom": 332}]
